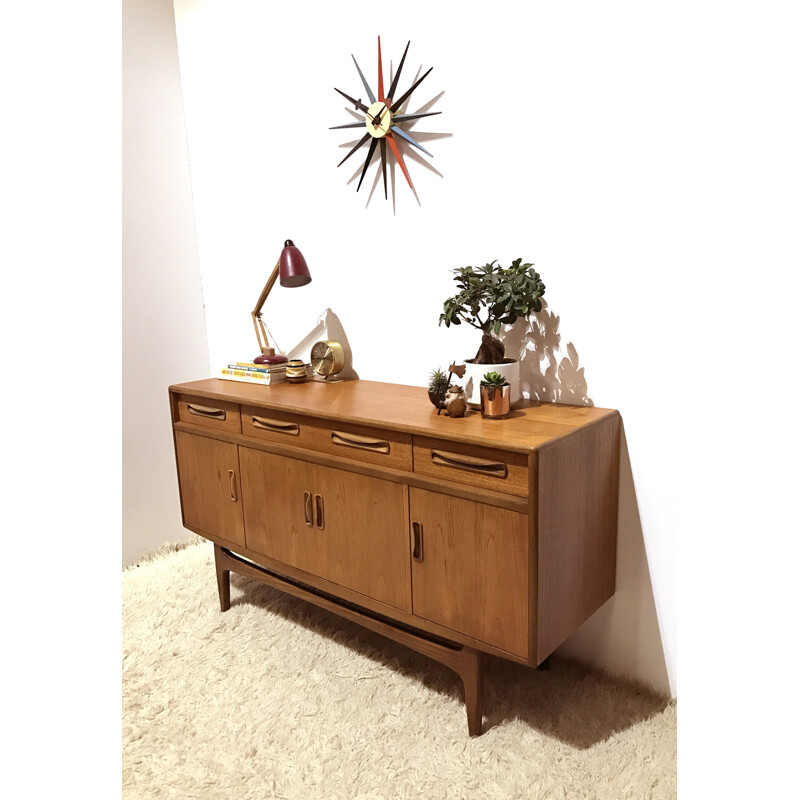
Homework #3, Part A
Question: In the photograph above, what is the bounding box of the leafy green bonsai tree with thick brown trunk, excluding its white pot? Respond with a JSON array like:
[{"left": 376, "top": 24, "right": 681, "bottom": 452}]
[{"left": 439, "top": 258, "right": 545, "bottom": 364}]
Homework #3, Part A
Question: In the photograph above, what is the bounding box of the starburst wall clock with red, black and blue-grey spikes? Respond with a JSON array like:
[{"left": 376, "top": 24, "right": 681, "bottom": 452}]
[{"left": 330, "top": 36, "right": 442, "bottom": 200}]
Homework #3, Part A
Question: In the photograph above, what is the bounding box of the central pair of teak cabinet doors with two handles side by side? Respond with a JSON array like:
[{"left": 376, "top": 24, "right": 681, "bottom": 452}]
[{"left": 239, "top": 447, "right": 411, "bottom": 611}]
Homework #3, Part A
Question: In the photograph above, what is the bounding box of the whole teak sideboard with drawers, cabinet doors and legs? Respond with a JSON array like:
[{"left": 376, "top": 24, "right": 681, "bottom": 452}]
[{"left": 169, "top": 378, "right": 620, "bottom": 735}]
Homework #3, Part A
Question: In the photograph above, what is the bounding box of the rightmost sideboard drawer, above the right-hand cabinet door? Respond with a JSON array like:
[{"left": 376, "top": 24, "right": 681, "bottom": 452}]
[{"left": 414, "top": 436, "right": 529, "bottom": 497}]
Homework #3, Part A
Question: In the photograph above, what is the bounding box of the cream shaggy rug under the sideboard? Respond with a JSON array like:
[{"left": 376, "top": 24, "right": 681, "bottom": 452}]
[{"left": 122, "top": 538, "right": 677, "bottom": 800}]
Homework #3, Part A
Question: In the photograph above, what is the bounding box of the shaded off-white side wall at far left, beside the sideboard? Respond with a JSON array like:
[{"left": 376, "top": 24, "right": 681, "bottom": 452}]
[{"left": 122, "top": 0, "right": 209, "bottom": 565}]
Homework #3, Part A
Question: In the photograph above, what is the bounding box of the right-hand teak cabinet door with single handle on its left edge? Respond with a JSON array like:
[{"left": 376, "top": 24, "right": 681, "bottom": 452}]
[{"left": 410, "top": 488, "right": 529, "bottom": 658}]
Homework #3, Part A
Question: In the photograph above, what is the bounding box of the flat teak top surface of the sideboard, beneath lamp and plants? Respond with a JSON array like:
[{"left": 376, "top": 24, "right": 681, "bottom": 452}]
[{"left": 169, "top": 378, "right": 619, "bottom": 451}]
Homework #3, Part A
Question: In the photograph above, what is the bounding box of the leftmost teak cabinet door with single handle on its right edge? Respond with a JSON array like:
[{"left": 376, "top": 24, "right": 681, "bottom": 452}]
[{"left": 175, "top": 431, "right": 244, "bottom": 545}]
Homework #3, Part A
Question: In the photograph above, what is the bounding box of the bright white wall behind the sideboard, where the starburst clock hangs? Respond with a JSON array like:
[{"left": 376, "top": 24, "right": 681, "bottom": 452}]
[{"left": 170, "top": 0, "right": 682, "bottom": 694}]
